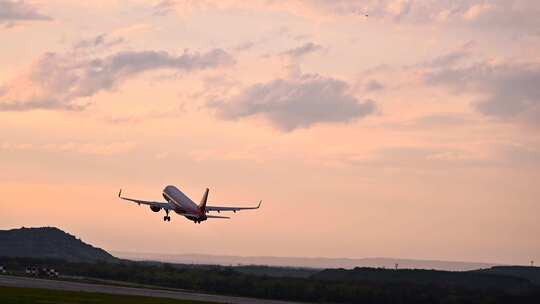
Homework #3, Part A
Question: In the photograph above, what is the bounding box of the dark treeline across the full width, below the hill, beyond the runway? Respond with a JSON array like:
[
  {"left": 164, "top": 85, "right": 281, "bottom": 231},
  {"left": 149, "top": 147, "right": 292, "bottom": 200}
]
[{"left": 0, "top": 258, "right": 540, "bottom": 304}]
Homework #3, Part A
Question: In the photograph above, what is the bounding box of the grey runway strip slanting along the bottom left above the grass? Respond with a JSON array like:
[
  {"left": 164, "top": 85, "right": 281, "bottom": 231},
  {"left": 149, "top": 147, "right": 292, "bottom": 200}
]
[{"left": 0, "top": 275, "right": 299, "bottom": 304}]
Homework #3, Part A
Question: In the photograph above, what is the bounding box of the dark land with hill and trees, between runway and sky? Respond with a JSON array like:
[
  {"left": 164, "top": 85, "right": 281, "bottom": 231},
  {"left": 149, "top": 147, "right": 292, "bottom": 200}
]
[{"left": 0, "top": 228, "right": 540, "bottom": 304}]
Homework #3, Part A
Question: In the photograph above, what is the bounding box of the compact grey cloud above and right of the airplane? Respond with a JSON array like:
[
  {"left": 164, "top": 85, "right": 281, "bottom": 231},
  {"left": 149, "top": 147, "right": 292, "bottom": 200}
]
[{"left": 209, "top": 74, "right": 376, "bottom": 132}]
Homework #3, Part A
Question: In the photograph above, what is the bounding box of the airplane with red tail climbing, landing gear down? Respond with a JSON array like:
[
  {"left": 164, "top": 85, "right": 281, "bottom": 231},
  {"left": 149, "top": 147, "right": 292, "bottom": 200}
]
[{"left": 118, "top": 185, "right": 262, "bottom": 224}]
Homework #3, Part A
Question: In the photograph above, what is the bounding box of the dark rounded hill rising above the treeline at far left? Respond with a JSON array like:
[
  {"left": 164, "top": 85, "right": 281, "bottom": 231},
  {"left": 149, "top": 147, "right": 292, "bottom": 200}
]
[{"left": 0, "top": 227, "right": 117, "bottom": 262}]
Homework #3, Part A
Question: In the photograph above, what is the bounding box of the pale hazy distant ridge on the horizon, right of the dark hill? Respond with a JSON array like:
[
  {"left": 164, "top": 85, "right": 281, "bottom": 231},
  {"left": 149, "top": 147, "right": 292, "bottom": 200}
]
[{"left": 114, "top": 251, "right": 498, "bottom": 271}]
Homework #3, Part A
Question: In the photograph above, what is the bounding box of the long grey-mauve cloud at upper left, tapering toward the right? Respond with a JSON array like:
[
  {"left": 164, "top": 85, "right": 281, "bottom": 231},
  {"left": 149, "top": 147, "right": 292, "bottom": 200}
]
[{"left": 0, "top": 37, "right": 234, "bottom": 111}]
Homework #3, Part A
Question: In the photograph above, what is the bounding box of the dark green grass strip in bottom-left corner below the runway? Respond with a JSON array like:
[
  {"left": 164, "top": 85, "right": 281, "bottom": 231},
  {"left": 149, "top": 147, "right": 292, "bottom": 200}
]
[{"left": 0, "top": 287, "right": 215, "bottom": 304}]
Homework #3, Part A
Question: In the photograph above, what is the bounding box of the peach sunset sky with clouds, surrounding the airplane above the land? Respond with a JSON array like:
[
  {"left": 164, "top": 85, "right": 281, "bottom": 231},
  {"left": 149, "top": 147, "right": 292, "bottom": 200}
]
[{"left": 0, "top": 0, "right": 540, "bottom": 265}]
